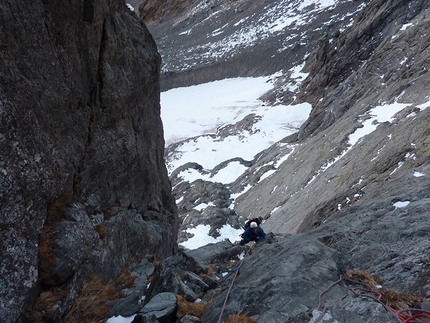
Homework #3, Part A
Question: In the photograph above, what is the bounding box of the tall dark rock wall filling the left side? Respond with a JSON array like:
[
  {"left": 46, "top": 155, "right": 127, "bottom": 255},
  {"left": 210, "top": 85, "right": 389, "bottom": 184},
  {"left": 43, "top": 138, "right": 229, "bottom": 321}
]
[{"left": 0, "top": 0, "right": 177, "bottom": 322}]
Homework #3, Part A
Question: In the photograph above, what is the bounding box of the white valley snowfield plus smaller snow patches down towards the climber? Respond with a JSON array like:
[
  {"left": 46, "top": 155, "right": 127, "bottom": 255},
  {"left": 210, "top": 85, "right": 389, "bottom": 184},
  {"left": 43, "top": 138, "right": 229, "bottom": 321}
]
[{"left": 161, "top": 77, "right": 311, "bottom": 248}]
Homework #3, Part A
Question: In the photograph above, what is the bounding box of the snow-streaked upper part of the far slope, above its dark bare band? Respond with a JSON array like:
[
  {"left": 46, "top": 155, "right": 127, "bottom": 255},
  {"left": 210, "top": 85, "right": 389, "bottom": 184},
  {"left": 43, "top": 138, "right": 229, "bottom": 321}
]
[{"left": 158, "top": 0, "right": 359, "bottom": 72}]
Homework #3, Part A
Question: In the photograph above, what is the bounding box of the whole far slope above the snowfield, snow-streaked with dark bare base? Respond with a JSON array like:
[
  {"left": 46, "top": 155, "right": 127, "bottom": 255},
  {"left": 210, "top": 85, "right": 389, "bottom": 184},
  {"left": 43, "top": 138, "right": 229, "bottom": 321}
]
[{"left": 139, "top": 0, "right": 363, "bottom": 90}]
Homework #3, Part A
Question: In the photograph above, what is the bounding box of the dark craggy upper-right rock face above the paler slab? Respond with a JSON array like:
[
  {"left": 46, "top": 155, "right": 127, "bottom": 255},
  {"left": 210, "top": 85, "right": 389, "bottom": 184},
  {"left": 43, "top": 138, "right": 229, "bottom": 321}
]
[{"left": 299, "top": 1, "right": 429, "bottom": 138}]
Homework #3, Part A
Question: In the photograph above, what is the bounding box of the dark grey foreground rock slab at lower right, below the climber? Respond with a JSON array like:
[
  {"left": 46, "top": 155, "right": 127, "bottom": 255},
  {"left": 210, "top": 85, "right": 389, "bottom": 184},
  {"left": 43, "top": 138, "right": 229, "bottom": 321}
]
[{"left": 201, "top": 198, "right": 430, "bottom": 323}]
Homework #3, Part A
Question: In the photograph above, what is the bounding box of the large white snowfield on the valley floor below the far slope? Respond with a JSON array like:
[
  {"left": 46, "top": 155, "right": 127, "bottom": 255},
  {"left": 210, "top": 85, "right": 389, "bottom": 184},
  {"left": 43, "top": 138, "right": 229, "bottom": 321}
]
[{"left": 161, "top": 77, "right": 312, "bottom": 183}]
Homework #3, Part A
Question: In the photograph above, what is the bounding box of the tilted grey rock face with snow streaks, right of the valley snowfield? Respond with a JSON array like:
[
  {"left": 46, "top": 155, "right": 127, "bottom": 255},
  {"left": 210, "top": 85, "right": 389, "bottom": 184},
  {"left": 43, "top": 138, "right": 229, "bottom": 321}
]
[{"left": 236, "top": 1, "right": 430, "bottom": 233}]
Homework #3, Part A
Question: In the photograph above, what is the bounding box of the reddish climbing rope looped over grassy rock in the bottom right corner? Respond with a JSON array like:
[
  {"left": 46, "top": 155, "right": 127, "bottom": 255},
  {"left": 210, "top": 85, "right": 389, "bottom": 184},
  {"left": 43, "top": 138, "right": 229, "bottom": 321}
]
[{"left": 314, "top": 275, "right": 430, "bottom": 323}]
